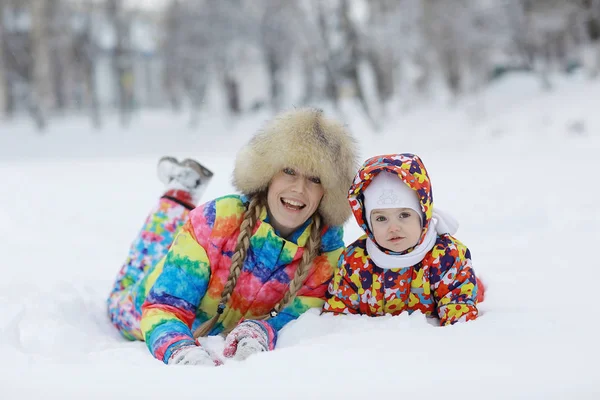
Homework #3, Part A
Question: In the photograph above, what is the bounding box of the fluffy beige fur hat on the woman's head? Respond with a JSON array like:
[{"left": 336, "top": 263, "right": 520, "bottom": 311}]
[{"left": 233, "top": 108, "right": 358, "bottom": 225}]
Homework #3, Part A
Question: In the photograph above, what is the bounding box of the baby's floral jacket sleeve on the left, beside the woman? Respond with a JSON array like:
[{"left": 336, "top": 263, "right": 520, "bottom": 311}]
[{"left": 323, "top": 250, "right": 360, "bottom": 314}]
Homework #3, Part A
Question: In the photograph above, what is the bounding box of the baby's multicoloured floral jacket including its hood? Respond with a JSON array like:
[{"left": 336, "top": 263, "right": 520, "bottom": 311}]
[{"left": 323, "top": 154, "right": 478, "bottom": 325}]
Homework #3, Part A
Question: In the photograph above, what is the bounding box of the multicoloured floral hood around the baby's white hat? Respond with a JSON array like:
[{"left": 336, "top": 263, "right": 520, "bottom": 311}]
[{"left": 348, "top": 153, "right": 433, "bottom": 253}]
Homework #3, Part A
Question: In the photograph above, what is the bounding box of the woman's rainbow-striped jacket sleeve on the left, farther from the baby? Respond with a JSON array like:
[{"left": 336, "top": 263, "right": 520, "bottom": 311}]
[{"left": 141, "top": 212, "right": 211, "bottom": 363}]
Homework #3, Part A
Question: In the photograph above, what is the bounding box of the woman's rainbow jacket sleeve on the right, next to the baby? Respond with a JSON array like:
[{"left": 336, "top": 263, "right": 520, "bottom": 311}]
[{"left": 267, "top": 227, "right": 344, "bottom": 340}]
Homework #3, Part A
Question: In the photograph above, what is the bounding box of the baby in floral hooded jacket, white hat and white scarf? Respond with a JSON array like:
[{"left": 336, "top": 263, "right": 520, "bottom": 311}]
[{"left": 323, "top": 154, "right": 483, "bottom": 325}]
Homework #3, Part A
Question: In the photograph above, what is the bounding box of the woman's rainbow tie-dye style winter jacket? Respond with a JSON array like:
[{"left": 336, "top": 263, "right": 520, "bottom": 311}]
[{"left": 141, "top": 195, "right": 344, "bottom": 363}]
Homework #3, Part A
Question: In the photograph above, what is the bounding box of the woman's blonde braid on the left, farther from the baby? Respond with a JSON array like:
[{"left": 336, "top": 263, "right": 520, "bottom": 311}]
[{"left": 194, "top": 195, "right": 263, "bottom": 339}]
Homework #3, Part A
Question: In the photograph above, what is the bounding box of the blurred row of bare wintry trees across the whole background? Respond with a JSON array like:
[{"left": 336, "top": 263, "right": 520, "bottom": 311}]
[{"left": 0, "top": 0, "right": 600, "bottom": 128}]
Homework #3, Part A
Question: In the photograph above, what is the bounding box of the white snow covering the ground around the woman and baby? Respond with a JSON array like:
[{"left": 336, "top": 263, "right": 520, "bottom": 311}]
[{"left": 0, "top": 75, "right": 600, "bottom": 400}]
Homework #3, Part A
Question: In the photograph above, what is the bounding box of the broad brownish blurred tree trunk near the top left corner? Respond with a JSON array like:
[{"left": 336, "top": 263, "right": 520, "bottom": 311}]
[{"left": 30, "top": 1, "right": 56, "bottom": 130}]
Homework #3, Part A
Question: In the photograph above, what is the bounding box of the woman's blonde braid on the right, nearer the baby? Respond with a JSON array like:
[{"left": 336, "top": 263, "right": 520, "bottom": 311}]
[{"left": 257, "top": 213, "right": 321, "bottom": 320}]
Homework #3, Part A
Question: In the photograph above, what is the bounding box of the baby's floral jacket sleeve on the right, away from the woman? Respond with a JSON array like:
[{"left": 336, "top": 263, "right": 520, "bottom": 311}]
[{"left": 431, "top": 235, "right": 478, "bottom": 325}]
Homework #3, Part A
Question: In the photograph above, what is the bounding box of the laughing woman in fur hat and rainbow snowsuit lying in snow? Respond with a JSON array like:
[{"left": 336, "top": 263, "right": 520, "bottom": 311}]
[{"left": 108, "top": 109, "right": 357, "bottom": 365}]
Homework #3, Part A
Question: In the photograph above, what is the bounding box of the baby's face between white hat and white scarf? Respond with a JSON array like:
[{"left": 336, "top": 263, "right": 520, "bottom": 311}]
[{"left": 371, "top": 208, "right": 421, "bottom": 253}]
